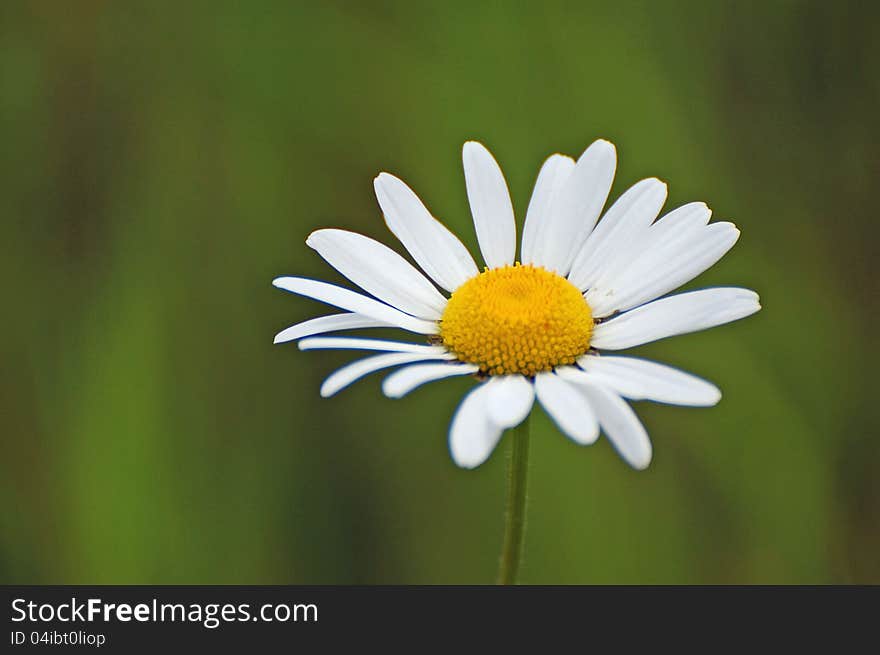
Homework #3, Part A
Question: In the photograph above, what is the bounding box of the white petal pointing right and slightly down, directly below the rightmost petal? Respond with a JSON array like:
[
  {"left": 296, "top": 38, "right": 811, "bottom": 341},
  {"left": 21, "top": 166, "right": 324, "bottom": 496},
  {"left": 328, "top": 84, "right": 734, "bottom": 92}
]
[{"left": 571, "top": 355, "right": 721, "bottom": 407}]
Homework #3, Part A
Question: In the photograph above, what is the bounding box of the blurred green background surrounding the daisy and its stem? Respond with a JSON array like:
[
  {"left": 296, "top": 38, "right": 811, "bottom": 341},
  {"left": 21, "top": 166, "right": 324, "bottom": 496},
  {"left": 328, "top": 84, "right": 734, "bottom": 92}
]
[{"left": 0, "top": 0, "right": 880, "bottom": 583}]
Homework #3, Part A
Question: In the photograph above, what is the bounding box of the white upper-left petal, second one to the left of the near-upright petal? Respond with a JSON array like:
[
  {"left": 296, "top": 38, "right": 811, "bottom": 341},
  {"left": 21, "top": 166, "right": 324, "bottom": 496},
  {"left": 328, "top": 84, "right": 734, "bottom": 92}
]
[{"left": 306, "top": 229, "right": 446, "bottom": 321}]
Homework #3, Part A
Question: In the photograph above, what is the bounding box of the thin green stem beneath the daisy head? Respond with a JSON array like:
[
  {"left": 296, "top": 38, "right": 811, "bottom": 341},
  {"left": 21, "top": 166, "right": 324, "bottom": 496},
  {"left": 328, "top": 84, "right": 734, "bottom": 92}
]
[{"left": 498, "top": 417, "right": 529, "bottom": 585}]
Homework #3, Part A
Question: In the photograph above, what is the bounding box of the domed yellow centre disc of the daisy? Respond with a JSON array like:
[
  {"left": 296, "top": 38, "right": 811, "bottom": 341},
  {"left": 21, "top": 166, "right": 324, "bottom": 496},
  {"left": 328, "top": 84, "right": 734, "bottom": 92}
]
[{"left": 440, "top": 264, "right": 593, "bottom": 376}]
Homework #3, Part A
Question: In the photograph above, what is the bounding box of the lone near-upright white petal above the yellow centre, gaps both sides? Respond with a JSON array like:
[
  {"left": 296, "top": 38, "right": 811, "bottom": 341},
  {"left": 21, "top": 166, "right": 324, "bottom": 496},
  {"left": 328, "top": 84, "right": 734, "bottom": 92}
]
[{"left": 461, "top": 141, "right": 516, "bottom": 268}]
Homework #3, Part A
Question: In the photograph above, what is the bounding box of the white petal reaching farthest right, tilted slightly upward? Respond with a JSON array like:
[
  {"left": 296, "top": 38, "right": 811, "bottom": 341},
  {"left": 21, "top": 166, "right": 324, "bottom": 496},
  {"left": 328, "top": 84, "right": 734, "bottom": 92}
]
[{"left": 590, "top": 287, "right": 761, "bottom": 350}]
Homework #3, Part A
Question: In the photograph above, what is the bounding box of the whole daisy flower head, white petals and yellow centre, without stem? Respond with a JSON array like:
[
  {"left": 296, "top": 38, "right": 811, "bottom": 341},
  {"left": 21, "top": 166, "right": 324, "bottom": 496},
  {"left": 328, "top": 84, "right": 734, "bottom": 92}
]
[{"left": 273, "top": 140, "right": 760, "bottom": 469}]
